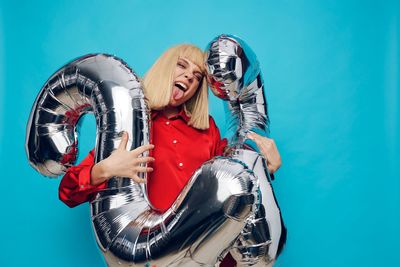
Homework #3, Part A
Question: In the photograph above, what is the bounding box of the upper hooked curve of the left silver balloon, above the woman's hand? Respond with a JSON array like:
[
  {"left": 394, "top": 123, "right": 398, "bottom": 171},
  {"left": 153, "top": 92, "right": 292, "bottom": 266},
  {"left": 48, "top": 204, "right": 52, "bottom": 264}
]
[{"left": 26, "top": 54, "right": 149, "bottom": 177}]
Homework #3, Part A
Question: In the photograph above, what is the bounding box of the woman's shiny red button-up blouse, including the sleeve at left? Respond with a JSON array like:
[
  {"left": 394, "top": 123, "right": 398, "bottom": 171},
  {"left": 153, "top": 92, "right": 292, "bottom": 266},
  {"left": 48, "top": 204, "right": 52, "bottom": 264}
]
[{"left": 59, "top": 111, "right": 227, "bottom": 211}]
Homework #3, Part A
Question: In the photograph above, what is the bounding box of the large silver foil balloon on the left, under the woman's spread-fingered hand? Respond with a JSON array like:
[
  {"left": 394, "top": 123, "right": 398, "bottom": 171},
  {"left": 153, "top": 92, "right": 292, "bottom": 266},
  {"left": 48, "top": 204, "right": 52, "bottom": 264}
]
[{"left": 26, "top": 54, "right": 259, "bottom": 266}]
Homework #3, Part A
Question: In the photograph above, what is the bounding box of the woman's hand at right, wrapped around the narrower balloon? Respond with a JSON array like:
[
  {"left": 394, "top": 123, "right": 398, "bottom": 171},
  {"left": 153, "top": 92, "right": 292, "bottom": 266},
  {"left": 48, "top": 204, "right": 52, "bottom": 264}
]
[{"left": 247, "top": 132, "right": 282, "bottom": 174}]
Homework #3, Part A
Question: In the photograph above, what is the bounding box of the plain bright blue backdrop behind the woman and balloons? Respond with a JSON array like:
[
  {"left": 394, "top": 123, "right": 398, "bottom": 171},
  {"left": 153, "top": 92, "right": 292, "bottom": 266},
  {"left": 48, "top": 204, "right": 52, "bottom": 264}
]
[{"left": 0, "top": 0, "right": 400, "bottom": 267}]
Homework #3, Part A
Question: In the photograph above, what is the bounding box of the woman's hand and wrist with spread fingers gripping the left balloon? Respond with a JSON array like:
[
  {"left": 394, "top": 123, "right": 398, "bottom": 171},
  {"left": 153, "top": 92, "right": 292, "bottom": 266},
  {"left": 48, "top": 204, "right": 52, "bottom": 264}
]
[{"left": 90, "top": 132, "right": 154, "bottom": 185}]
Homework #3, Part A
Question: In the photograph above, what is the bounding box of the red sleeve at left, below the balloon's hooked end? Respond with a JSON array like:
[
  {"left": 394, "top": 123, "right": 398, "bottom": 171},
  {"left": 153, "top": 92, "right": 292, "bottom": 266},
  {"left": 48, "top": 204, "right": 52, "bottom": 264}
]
[{"left": 58, "top": 150, "right": 106, "bottom": 208}]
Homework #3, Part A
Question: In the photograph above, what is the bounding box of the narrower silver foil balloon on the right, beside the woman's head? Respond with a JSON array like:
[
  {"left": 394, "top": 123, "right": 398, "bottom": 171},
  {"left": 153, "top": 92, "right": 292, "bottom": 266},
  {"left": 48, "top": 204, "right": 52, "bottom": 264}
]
[{"left": 206, "top": 35, "right": 286, "bottom": 266}]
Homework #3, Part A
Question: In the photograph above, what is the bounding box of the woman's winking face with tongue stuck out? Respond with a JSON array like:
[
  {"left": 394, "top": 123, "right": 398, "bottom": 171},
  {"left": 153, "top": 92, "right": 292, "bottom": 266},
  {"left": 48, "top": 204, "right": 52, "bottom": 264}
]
[{"left": 169, "top": 57, "right": 203, "bottom": 107}]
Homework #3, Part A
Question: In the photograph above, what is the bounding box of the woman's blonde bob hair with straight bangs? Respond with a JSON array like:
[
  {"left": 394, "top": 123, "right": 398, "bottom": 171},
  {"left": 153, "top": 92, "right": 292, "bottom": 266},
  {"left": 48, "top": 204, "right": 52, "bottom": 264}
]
[{"left": 143, "top": 44, "right": 209, "bottom": 130}]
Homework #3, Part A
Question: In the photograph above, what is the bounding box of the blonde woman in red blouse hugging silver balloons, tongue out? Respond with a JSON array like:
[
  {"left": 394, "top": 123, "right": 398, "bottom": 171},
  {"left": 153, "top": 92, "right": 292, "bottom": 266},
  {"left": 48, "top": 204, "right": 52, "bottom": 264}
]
[{"left": 59, "top": 45, "right": 281, "bottom": 266}]
